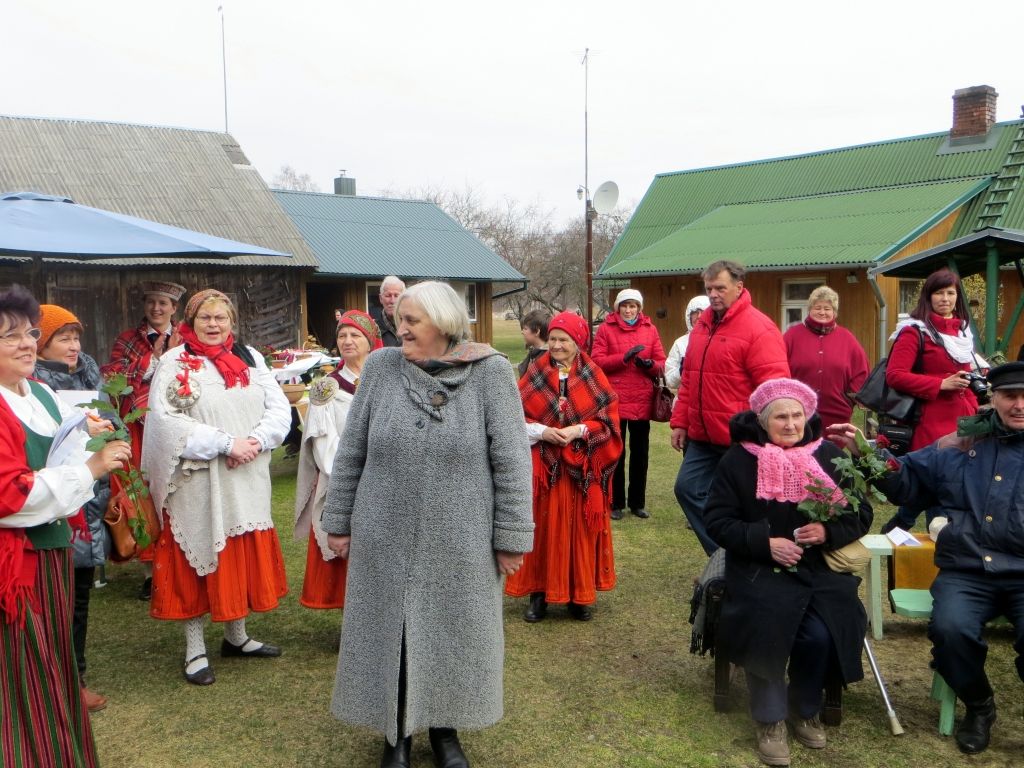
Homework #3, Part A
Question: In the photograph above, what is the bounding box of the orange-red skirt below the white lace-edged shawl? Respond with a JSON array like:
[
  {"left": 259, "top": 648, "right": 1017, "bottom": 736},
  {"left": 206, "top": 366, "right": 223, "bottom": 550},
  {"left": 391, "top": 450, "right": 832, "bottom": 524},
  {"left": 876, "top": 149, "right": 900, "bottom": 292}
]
[{"left": 150, "top": 515, "right": 288, "bottom": 622}]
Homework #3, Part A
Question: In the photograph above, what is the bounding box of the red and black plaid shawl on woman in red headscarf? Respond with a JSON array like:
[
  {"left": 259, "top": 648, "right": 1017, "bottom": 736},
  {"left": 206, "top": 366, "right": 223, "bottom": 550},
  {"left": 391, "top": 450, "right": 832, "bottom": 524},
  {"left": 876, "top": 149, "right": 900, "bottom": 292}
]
[{"left": 519, "top": 350, "right": 623, "bottom": 529}]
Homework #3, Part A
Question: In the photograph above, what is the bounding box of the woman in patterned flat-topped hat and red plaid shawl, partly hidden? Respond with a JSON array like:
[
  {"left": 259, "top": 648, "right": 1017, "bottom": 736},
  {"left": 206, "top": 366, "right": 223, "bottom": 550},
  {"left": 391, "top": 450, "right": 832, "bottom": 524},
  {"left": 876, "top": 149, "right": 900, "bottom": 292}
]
[{"left": 100, "top": 281, "right": 185, "bottom": 600}]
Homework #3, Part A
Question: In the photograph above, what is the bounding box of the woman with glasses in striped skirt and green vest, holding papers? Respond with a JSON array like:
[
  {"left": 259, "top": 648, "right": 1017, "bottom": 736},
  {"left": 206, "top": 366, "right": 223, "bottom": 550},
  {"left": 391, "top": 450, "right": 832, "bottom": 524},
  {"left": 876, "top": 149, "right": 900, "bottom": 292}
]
[{"left": 0, "top": 286, "right": 130, "bottom": 768}]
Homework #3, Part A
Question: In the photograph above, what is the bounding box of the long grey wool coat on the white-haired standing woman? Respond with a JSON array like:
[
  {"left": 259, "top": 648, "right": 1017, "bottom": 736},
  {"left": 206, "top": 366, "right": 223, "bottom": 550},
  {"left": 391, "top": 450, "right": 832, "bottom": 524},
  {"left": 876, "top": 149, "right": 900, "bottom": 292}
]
[{"left": 323, "top": 348, "right": 534, "bottom": 743}]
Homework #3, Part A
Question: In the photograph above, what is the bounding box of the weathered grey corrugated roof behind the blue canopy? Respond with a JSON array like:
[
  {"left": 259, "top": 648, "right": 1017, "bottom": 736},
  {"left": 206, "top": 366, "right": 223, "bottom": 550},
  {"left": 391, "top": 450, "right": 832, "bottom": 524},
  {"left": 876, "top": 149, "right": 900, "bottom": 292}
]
[{"left": 0, "top": 116, "right": 316, "bottom": 267}]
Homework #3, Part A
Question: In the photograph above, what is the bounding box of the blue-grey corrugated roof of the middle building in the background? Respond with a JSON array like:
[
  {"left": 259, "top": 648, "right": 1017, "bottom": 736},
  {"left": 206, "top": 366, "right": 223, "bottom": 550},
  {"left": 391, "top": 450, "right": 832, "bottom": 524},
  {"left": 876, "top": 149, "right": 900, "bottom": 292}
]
[{"left": 273, "top": 189, "right": 525, "bottom": 282}]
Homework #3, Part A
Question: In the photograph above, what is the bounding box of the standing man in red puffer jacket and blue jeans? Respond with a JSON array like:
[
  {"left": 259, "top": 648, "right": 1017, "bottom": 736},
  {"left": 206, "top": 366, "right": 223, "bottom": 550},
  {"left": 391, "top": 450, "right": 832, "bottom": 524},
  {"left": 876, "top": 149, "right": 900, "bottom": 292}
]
[{"left": 669, "top": 261, "right": 790, "bottom": 555}]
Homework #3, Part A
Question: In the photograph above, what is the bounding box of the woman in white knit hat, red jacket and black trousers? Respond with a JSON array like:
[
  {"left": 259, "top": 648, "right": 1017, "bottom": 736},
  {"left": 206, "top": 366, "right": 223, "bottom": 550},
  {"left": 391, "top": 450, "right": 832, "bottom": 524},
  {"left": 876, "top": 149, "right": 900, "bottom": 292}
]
[{"left": 591, "top": 288, "right": 665, "bottom": 520}]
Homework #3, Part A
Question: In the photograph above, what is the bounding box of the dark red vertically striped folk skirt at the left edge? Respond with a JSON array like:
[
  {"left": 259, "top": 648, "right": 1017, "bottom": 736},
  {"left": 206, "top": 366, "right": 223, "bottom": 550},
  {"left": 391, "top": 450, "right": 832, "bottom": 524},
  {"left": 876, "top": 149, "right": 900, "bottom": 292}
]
[{"left": 0, "top": 548, "right": 99, "bottom": 768}]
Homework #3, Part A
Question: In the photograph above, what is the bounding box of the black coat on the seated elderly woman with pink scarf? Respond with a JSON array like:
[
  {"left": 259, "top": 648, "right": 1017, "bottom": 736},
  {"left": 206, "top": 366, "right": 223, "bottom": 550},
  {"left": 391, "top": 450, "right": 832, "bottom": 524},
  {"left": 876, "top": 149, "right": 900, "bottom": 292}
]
[{"left": 703, "top": 411, "right": 872, "bottom": 683}]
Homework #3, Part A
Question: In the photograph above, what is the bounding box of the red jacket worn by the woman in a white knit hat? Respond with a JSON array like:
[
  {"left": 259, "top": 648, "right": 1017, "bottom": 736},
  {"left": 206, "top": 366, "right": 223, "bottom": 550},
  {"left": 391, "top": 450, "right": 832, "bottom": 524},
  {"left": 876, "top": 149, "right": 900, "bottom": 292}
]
[{"left": 590, "top": 312, "right": 665, "bottom": 421}]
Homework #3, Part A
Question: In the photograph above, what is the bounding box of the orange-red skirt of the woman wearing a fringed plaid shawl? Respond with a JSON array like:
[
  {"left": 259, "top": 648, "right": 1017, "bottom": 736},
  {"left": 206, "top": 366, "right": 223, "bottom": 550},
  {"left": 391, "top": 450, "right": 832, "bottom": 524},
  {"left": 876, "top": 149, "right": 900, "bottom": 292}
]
[{"left": 505, "top": 472, "right": 615, "bottom": 605}]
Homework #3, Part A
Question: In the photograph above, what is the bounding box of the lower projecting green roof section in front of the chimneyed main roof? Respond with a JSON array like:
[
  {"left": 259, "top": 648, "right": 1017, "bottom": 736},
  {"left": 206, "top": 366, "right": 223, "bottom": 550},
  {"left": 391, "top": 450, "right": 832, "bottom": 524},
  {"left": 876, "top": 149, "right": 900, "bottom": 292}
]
[{"left": 602, "top": 179, "right": 989, "bottom": 276}]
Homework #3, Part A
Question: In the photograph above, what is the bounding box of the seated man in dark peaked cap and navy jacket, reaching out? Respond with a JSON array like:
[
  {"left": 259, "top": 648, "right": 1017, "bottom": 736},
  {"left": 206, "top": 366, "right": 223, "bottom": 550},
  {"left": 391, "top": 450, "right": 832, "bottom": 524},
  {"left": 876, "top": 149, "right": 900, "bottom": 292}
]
[{"left": 830, "top": 362, "right": 1024, "bottom": 755}]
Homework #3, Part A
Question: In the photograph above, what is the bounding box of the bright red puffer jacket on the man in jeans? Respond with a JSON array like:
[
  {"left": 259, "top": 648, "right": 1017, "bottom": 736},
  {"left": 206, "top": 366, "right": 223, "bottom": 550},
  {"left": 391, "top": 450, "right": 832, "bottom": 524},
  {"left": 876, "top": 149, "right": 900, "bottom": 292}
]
[{"left": 670, "top": 288, "right": 790, "bottom": 445}]
